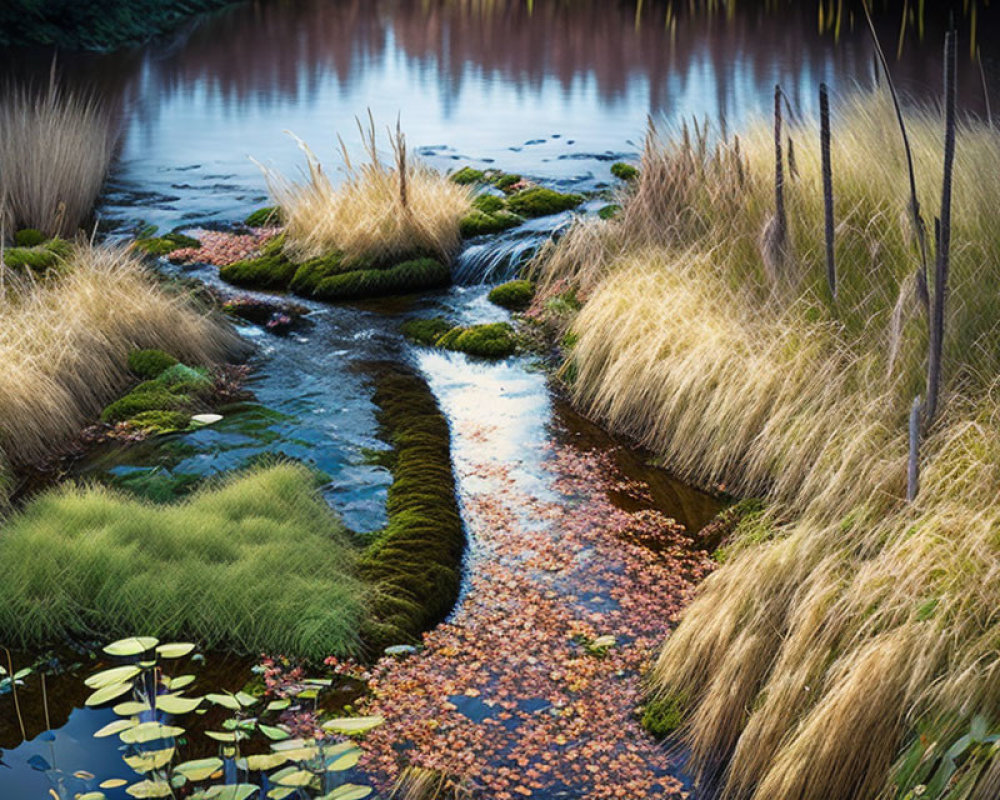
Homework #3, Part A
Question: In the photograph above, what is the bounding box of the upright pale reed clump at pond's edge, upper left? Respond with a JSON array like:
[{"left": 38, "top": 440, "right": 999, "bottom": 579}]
[{"left": 0, "top": 77, "right": 118, "bottom": 236}]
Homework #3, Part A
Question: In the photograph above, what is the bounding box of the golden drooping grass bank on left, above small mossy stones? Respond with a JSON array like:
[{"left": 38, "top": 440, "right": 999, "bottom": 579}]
[{"left": 0, "top": 245, "right": 240, "bottom": 465}]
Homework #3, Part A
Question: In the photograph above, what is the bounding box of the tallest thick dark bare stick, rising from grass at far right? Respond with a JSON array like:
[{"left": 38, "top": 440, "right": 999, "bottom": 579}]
[{"left": 925, "top": 31, "right": 958, "bottom": 427}]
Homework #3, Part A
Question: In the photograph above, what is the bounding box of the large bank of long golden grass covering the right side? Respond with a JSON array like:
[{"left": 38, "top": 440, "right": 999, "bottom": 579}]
[{"left": 536, "top": 96, "right": 1000, "bottom": 800}]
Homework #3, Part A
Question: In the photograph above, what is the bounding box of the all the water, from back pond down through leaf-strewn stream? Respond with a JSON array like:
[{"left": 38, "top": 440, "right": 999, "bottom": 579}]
[{"left": 0, "top": 0, "right": 1000, "bottom": 800}]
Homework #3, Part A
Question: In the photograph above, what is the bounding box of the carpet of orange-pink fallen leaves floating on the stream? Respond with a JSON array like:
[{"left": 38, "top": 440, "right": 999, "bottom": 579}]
[{"left": 365, "top": 427, "right": 711, "bottom": 800}]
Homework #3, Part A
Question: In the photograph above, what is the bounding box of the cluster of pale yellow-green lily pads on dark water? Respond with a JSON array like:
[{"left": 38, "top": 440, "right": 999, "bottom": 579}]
[{"left": 77, "top": 636, "right": 383, "bottom": 800}]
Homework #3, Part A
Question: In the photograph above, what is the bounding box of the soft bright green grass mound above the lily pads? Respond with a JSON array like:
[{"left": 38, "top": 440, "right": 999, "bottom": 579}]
[{"left": 0, "top": 464, "right": 366, "bottom": 659}]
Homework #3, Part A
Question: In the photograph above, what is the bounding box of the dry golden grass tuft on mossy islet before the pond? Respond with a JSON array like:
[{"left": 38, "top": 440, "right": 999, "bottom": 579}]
[{"left": 254, "top": 116, "right": 472, "bottom": 265}]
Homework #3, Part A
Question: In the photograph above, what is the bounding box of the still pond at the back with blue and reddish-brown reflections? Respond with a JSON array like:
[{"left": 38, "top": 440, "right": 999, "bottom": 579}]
[{"left": 5, "top": 0, "right": 1000, "bottom": 227}]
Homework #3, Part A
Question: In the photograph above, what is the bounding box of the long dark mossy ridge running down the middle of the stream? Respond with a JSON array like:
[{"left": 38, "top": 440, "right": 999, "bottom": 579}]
[{"left": 361, "top": 365, "right": 465, "bottom": 652}]
